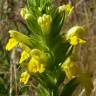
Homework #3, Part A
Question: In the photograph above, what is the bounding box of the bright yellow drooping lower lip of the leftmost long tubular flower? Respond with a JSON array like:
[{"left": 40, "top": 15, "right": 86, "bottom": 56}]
[{"left": 6, "top": 38, "right": 18, "bottom": 51}]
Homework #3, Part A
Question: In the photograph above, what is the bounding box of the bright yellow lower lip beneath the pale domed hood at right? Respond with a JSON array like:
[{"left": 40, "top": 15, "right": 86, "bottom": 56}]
[{"left": 70, "top": 36, "right": 86, "bottom": 46}]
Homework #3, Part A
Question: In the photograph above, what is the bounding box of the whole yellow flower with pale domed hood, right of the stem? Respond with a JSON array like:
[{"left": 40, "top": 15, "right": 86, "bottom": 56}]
[{"left": 66, "top": 26, "right": 86, "bottom": 46}]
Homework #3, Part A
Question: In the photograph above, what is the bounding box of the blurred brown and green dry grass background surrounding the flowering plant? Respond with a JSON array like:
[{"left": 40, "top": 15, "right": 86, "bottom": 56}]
[{"left": 0, "top": 0, "right": 96, "bottom": 96}]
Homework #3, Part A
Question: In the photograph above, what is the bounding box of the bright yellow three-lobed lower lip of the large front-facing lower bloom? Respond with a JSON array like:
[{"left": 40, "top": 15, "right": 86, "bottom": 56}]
[{"left": 28, "top": 56, "right": 45, "bottom": 73}]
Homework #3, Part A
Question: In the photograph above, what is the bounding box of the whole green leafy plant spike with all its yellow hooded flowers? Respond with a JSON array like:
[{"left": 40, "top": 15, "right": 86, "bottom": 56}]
[{"left": 6, "top": 0, "right": 93, "bottom": 96}]
